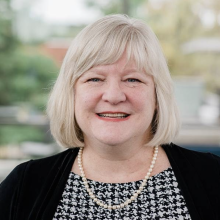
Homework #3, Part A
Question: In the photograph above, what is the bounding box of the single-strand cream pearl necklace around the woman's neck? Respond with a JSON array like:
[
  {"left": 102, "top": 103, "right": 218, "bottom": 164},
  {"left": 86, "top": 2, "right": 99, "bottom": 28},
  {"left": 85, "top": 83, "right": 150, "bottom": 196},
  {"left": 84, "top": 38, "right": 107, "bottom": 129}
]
[{"left": 78, "top": 146, "right": 158, "bottom": 210}]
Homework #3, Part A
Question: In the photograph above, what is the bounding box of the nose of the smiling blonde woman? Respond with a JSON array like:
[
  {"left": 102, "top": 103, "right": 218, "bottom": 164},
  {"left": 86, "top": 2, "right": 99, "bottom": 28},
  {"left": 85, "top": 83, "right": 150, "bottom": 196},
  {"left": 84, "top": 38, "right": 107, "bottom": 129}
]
[{"left": 102, "top": 81, "right": 126, "bottom": 105}]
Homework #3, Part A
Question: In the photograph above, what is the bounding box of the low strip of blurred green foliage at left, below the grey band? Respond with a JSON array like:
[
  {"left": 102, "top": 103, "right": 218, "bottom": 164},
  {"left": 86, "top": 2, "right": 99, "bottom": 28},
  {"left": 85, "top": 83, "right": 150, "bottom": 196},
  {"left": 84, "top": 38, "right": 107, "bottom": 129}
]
[{"left": 0, "top": 125, "right": 44, "bottom": 145}]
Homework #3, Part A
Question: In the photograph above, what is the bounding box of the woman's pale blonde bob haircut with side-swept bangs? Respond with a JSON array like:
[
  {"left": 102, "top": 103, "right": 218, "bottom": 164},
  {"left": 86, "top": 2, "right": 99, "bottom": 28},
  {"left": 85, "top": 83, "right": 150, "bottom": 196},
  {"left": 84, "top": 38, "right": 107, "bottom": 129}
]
[{"left": 47, "top": 15, "right": 180, "bottom": 148}]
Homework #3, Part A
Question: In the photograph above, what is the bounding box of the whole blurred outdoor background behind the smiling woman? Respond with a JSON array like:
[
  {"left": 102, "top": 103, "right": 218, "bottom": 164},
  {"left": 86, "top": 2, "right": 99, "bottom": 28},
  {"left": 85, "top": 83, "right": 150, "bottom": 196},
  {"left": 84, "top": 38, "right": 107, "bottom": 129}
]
[{"left": 0, "top": 0, "right": 220, "bottom": 181}]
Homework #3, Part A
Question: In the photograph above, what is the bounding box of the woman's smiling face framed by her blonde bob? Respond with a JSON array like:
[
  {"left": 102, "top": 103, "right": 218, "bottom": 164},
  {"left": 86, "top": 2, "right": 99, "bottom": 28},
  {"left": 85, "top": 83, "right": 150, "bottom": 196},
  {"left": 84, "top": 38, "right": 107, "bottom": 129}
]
[{"left": 75, "top": 53, "right": 156, "bottom": 146}]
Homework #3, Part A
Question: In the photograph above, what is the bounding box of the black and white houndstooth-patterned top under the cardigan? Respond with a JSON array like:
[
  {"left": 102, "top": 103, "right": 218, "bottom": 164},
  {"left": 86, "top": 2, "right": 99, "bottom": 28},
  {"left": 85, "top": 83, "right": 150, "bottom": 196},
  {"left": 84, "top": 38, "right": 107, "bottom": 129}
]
[{"left": 53, "top": 168, "right": 191, "bottom": 220}]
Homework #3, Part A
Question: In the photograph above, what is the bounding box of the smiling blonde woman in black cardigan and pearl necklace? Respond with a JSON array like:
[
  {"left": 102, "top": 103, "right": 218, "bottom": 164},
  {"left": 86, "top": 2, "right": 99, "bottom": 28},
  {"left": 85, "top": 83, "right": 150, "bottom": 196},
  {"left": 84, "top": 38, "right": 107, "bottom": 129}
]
[{"left": 0, "top": 15, "right": 220, "bottom": 220}]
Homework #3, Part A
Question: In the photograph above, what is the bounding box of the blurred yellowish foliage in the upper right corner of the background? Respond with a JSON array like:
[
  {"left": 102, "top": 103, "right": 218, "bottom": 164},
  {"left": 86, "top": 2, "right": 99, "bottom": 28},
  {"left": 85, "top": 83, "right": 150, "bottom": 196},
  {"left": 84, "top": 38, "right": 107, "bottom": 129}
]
[{"left": 145, "top": 0, "right": 220, "bottom": 90}]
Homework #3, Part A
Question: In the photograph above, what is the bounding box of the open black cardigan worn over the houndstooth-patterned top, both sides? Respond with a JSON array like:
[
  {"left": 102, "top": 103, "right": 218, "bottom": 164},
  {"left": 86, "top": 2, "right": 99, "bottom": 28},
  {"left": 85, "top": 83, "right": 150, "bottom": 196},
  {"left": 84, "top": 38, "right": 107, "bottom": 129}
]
[{"left": 0, "top": 144, "right": 220, "bottom": 220}]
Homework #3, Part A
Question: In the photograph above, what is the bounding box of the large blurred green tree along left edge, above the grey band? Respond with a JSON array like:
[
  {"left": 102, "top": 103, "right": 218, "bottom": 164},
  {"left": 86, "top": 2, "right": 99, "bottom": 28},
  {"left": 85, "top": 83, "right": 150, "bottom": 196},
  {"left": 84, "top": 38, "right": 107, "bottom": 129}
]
[{"left": 0, "top": 0, "right": 58, "bottom": 109}]
